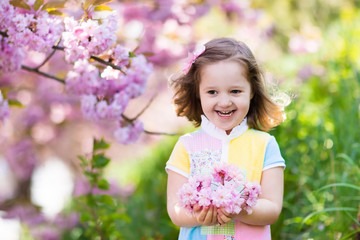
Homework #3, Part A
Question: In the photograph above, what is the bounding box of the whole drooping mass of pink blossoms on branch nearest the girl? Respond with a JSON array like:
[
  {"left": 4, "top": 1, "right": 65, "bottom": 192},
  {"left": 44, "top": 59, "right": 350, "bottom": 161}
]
[{"left": 62, "top": 11, "right": 153, "bottom": 144}]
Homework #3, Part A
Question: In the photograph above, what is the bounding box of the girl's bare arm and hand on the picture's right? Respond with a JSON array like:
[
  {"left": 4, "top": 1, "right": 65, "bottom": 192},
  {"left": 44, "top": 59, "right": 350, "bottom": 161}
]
[{"left": 218, "top": 167, "right": 284, "bottom": 225}]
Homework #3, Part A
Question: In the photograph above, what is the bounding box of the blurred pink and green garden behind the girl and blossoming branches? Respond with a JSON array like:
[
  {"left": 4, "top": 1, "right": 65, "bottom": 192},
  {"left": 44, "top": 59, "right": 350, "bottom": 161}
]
[{"left": 0, "top": 0, "right": 360, "bottom": 240}]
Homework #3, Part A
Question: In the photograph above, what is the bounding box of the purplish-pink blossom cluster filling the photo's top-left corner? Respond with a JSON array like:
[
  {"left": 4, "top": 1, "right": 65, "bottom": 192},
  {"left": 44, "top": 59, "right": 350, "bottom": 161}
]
[{"left": 0, "top": 0, "right": 64, "bottom": 72}]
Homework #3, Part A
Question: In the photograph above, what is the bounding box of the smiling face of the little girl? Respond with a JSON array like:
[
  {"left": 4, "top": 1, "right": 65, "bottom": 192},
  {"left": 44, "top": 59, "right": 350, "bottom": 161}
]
[{"left": 199, "top": 61, "right": 252, "bottom": 134}]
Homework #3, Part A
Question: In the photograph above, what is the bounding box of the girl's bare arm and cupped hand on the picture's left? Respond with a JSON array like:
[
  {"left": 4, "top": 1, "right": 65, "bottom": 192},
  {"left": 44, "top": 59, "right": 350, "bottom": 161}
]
[{"left": 167, "top": 170, "right": 218, "bottom": 227}]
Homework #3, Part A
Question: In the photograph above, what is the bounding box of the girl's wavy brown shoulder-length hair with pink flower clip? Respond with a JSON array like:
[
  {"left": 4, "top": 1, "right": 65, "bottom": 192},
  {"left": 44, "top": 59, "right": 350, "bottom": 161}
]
[{"left": 170, "top": 38, "right": 284, "bottom": 131}]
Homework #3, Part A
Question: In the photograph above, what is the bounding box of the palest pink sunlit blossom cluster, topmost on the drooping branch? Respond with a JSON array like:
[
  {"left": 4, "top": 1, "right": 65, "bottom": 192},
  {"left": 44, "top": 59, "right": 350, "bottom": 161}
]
[{"left": 62, "top": 11, "right": 118, "bottom": 63}]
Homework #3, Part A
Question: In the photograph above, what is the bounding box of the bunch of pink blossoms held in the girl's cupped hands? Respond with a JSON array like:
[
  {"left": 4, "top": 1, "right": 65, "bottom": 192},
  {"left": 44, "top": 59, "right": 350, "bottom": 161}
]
[{"left": 178, "top": 163, "right": 261, "bottom": 214}]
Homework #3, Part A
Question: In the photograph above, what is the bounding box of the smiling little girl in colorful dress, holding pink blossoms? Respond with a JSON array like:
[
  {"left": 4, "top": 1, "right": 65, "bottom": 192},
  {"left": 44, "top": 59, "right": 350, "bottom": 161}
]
[{"left": 166, "top": 38, "right": 285, "bottom": 240}]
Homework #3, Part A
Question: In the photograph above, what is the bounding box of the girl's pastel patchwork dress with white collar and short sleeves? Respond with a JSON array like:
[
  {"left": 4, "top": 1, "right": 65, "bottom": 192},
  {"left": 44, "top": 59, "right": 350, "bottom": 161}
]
[{"left": 166, "top": 116, "right": 285, "bottom": 240}]
